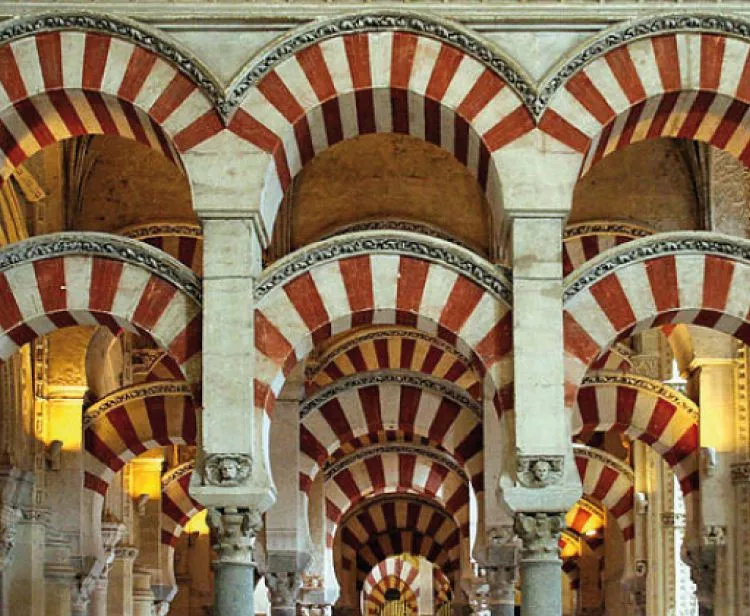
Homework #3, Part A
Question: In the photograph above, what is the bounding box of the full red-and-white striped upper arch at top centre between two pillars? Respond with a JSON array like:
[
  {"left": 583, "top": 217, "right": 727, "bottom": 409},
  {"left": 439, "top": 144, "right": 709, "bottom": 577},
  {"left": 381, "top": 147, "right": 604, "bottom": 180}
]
[{"left": 235, "top": 24, "right": 534, "bottom": 228}]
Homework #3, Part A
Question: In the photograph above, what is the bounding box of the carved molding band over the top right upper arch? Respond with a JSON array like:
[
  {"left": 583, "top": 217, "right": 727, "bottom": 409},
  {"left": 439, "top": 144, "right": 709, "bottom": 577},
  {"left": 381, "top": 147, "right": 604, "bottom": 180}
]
[{"left": 530, "top": 13, "right": 750, "bottom": 119}]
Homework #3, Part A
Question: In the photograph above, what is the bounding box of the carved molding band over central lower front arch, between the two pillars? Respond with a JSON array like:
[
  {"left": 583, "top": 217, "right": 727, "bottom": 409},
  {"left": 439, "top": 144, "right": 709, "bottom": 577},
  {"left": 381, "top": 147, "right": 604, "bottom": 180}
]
[{"left": 254, "top": 231, "right": 513, "bottom": 306}]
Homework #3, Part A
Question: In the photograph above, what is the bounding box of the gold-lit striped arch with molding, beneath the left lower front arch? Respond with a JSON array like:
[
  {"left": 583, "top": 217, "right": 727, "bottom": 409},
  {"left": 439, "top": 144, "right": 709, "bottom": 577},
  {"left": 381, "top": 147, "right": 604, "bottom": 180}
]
[{"left": 83, "top": 381, "right": 197, "bottom": 497}]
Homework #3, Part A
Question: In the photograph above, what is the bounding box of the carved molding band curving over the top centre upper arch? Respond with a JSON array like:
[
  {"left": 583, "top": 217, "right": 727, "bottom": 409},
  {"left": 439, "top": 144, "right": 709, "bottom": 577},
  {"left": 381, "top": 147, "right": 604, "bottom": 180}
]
[{"left": 226, "top": 9, "right": 536, "bottom": 117}]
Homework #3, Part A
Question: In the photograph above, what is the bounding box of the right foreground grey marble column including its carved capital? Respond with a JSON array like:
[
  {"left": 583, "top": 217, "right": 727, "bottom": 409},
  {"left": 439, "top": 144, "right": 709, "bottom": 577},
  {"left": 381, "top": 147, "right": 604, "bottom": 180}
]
[{"left": 515, "top": 512, "right": 565, "bottom": 616}]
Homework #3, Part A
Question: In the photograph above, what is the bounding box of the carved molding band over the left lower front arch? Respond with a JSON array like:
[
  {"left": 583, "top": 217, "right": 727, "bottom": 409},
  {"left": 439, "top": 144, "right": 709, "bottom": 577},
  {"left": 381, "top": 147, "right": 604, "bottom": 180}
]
[{"left": 0, "top": 231, "right": 203, "bottom": 305}]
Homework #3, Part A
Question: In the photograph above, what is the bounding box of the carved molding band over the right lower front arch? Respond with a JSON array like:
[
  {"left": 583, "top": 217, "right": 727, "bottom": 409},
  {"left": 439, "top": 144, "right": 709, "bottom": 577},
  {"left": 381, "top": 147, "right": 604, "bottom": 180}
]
[{"left": 563, "top": 231, "right": 750, "bottom": 305}]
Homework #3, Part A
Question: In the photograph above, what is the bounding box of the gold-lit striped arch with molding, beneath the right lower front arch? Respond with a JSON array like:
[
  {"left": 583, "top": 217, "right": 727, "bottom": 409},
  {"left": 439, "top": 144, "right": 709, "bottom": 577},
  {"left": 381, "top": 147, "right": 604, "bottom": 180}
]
[{"left": 571, "top": 374, "right": 699, "bottom": 494}]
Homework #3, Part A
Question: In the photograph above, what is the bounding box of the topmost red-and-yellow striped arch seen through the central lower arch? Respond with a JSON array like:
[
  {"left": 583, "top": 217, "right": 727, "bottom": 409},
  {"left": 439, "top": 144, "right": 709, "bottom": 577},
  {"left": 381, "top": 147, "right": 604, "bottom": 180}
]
[{"left": 306, "top": 328, "right": 482, "bottom": 400}]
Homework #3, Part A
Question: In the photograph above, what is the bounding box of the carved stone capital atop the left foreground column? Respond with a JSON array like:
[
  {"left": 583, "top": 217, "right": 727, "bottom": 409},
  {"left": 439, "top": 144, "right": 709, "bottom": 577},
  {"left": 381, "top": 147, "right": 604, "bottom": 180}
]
[{"left": 207, "top": 507, "right": 263, "bottom": 565}]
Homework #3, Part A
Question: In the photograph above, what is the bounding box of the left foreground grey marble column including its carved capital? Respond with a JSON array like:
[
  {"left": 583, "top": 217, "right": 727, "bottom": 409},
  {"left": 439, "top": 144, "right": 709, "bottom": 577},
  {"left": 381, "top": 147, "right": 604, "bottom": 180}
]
[{"left": 207, "top": 507, "right": 263, "bottom": 616}]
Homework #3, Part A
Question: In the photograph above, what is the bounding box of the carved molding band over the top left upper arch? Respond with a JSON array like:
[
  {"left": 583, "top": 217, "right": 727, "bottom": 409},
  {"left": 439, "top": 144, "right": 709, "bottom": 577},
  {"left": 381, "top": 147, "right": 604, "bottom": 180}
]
[{"left": 0, "top": 10, "right": 223, "bottom": 113}]
